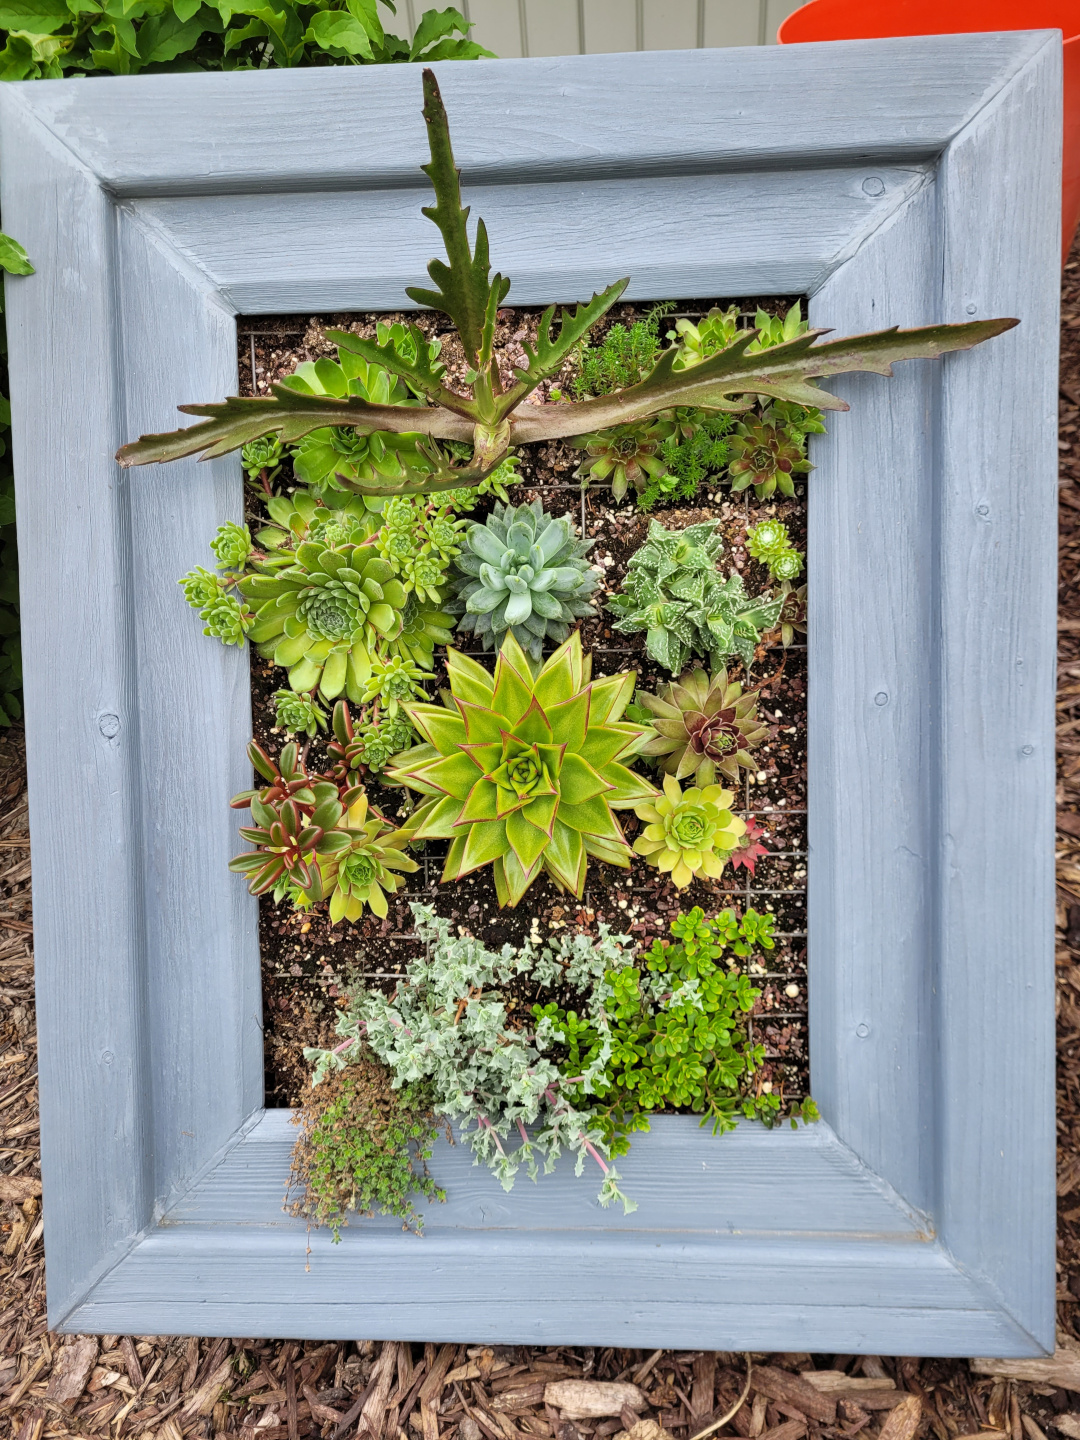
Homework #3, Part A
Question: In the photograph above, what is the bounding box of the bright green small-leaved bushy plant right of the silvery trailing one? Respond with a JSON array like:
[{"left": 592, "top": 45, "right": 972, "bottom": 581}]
[{"left": 544, "top": 906, "right": 819, "bottom": 1156}]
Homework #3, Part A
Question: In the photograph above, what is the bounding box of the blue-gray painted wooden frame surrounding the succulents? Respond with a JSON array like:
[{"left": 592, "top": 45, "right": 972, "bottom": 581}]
[{"left": 0, "top": 32, "right": 1061, "bottom": 1356}]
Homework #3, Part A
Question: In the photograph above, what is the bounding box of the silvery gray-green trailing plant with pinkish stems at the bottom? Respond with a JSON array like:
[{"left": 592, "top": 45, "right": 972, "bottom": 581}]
[{"left": 304, "top": 904, "right": 636, "bottom": 1211}]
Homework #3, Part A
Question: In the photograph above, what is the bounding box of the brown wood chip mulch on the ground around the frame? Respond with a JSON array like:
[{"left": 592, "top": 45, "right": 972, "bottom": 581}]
[{"left": 10, "top": 246, "right": 1080, "bottom": 1440}]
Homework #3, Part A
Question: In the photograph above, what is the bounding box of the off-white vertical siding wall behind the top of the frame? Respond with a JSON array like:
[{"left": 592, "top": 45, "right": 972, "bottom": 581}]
[{"left": 392, "top": 0, "right": 802, "bottom": 59}]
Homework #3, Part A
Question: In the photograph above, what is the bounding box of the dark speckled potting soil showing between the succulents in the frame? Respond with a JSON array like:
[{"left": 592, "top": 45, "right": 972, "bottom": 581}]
[{"left": 238, "top": 298, "right": 809, "bottom": 1106}]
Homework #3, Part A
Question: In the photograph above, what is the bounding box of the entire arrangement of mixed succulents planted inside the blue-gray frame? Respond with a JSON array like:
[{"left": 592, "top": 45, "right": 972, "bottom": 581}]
[{"left": 118, "top": 73, "right": 1014, "bottom": 1228}]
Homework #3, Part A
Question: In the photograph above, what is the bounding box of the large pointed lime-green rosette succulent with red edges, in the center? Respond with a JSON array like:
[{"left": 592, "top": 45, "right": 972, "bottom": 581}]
[{"left": 386, "top": 632, "right": 657, "bottom": 906}]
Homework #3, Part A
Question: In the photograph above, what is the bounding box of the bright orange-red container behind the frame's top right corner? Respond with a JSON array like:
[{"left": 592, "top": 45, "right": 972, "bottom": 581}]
[{"left": 776, "top": 0, "right": 1080, "bottom": 265}]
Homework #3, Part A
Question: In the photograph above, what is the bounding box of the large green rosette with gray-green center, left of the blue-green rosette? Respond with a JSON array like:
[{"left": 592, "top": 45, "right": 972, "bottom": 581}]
[{"left": 238, "top": 540, "right": 406, "bottom": 703}]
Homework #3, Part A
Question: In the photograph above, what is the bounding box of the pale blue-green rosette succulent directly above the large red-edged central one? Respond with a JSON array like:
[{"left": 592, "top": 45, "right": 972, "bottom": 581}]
[{"left": 446, "top": 500, "right": 598, "bottom": 660}]
